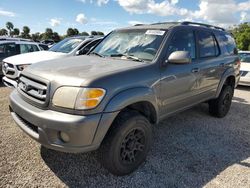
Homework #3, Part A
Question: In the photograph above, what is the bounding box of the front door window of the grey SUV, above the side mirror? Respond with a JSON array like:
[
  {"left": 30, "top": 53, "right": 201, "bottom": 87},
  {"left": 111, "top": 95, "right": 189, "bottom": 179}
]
[{"left": 167, "top": 31, "right": 195, "bottom": 59}]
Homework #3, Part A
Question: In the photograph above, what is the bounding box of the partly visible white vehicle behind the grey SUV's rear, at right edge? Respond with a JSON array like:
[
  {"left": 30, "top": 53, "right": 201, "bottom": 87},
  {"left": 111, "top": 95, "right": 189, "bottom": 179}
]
[{"left": 239, "top": 53, "right": 250, "bottom": 86}]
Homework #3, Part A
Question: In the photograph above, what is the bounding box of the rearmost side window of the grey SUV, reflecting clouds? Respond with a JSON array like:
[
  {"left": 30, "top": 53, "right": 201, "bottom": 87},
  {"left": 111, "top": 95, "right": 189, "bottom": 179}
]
[{"left": 219, "top": 34, "right": 237, "bottom": 55}]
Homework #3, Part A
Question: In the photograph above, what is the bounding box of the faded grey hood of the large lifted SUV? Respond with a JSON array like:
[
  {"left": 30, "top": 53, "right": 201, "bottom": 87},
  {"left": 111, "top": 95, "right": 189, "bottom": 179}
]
[{"left": 23, "top": 55, "right": 148, "bottom": 86}]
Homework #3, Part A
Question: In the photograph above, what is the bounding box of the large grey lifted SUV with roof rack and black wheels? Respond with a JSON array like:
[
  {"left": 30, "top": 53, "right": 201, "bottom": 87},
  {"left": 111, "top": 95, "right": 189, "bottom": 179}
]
[{"left": 10, "top": 22, "right": 239, "bottom": 175}]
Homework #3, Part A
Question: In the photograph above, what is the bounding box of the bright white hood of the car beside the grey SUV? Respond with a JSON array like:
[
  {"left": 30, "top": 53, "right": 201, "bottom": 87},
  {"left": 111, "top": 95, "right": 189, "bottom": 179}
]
[{"left": 3, "top": 51, "right": 68, "bottom": 65}]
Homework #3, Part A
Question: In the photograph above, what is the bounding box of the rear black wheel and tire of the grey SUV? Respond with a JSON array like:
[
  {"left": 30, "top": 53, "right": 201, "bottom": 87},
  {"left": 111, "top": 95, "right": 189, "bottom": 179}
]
[{"left": 209, "top": 85, "right": 234, "bottom": 118}]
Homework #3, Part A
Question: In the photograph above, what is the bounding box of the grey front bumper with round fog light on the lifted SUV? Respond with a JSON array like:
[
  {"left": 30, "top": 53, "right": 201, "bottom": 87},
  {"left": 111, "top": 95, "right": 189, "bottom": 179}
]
[{"left": 10, "top": 90, "right": 115, "bottom": 153}]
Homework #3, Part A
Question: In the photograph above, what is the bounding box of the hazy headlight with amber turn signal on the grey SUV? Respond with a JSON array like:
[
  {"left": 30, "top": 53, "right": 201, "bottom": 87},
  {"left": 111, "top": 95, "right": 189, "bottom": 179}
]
[{"left": 52, "top": 87, "right": 106, "bottom": 110}]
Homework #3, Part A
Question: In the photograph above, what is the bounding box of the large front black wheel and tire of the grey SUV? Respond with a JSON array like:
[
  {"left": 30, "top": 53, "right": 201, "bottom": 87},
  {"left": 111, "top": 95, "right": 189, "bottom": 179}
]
[{"left": 99, "top": 111, "right": 152, "bottom": 176}]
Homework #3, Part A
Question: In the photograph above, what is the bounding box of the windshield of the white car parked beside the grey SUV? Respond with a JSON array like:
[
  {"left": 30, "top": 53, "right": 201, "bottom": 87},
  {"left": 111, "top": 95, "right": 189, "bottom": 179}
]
[{"left": 49, "top": 38, "right": 83, "bottom": 53}]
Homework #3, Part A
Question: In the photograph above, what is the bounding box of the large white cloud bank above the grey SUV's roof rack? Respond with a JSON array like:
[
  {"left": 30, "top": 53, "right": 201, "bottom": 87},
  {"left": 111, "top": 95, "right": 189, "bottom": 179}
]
[{"left": 117, "top": 0, "right": 250, "bottom": 25}]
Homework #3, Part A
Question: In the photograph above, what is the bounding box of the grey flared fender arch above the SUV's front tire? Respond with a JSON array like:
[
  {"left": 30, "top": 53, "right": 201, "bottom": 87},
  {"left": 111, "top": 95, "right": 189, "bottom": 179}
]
[{"left": 104, "top": 87, "right": 158, "bottom": 117}]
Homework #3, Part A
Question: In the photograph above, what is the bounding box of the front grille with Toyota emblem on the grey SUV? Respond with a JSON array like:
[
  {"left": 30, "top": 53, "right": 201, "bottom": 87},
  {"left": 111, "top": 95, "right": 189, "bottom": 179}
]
[{"left": 18, "top": 76, "right": 47, "bottom": 103}]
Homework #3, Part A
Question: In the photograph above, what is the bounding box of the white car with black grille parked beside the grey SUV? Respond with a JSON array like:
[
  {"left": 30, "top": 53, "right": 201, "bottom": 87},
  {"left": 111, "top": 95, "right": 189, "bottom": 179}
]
[{"left": 3, "top": 37, "right": 102, "bottom": 87}]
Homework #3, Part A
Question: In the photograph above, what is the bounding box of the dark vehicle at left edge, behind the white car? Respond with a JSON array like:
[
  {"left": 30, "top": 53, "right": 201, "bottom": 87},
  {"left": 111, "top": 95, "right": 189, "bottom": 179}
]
[{"left": 0, "top": 40, "right": 46, "bottom": 76}]
